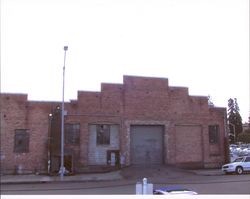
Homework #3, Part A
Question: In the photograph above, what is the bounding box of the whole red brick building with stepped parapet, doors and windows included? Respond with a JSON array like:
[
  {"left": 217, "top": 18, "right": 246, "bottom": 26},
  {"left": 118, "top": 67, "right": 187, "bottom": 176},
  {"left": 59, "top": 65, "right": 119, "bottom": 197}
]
[{"left": 1, "top": 76, "right": 227, "bottom": 173}]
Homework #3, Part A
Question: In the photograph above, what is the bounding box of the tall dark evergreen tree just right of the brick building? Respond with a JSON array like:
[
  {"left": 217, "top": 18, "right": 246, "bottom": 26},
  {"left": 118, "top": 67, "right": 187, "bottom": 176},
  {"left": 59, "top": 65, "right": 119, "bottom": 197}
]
[{"left": 227, "top": 98, "right": 243, "bottom": 144}]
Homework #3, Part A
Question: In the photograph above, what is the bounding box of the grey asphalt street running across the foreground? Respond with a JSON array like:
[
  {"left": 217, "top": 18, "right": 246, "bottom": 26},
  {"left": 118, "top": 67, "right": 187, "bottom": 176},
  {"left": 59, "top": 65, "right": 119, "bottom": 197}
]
[{"left": 1, "top": 169, "right": 250, "bottom": 195}]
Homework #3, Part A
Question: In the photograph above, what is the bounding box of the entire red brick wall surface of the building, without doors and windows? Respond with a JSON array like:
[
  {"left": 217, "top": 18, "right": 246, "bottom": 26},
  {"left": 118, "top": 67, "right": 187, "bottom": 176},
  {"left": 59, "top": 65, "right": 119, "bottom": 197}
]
[{"left": 0, "top": 76, "right": 226, "bottom": 172}]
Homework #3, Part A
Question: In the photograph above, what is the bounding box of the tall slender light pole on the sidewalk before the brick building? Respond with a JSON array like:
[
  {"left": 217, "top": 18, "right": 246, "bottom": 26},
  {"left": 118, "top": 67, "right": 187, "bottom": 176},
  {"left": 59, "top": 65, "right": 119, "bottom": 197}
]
[{"left": 59, "top": 46, "right": 68, "bottom": 180}]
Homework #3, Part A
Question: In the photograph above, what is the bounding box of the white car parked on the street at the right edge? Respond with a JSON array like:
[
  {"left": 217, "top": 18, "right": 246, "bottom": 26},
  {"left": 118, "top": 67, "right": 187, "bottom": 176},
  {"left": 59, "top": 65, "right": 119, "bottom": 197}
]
[{"left": 222, "top": 156, "right": 250, "bottom": 174}]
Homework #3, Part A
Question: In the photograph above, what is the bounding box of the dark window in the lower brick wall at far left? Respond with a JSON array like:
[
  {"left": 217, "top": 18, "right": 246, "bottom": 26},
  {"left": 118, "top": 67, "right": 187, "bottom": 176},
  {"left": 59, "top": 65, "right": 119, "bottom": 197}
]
[{"left": 14, "top": 129, "right": 29, "bottom": 153}]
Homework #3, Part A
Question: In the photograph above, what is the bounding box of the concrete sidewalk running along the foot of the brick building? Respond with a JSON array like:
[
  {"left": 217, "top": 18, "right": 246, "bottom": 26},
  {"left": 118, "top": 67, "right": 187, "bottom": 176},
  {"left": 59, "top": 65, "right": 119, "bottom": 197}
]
[{"left": 0, "top": 167, "right": 223, "bottom": 184}]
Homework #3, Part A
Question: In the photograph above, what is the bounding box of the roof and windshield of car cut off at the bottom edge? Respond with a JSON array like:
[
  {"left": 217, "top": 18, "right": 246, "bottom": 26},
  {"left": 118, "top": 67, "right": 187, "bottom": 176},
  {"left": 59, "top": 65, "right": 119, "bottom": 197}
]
[{"left": 153, "top": 186, "right": 197, "bottom": 195}]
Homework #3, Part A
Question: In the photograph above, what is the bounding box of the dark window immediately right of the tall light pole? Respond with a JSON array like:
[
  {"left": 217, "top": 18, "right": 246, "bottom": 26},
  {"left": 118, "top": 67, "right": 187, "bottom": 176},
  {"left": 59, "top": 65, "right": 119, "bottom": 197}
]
[{"left": 65, "top": 124, "right": 80, "bottom": 144}]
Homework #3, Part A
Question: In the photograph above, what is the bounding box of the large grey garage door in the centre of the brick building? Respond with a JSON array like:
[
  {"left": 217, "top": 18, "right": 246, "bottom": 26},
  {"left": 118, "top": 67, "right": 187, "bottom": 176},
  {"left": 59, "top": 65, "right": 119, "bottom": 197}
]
[{"left": 130, "top": 125, "right": 164, "bottom": 165}]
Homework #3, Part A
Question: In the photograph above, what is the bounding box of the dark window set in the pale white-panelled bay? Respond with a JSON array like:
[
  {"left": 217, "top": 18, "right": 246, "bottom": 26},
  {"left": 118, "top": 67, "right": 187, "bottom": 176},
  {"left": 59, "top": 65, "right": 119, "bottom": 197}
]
[{"left": 96, "top": 125, "right": 110, "bottom": 145}]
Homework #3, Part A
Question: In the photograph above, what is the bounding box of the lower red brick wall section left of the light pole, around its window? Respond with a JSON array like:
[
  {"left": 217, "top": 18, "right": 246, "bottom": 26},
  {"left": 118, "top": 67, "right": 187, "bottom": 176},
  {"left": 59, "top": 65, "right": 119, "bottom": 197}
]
[{"left": 1, "top": 94, "right": 59, "bottom": 173}]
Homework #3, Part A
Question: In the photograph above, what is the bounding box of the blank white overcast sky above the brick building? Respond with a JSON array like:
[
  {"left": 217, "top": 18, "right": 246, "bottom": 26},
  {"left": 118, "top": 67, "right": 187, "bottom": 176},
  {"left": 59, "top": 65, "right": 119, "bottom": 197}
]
[{"left": 1, "top": 0, "right": 250, "bottom": 122}]
